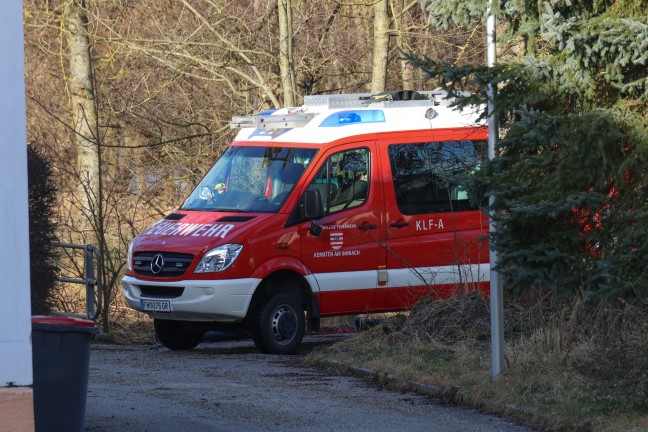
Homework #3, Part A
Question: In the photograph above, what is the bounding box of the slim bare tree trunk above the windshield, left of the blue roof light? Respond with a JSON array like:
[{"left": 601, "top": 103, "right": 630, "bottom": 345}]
[{"left": 277, "top": 0, "right": 296, "bottom": 107}]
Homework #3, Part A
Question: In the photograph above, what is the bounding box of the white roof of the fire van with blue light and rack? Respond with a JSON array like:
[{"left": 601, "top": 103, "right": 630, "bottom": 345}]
[{"left": 231, "top": 91, "right": 484, "bottom": 143}]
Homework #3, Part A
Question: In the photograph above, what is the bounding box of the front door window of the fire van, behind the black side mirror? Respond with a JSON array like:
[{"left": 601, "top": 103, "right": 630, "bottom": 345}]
[{"left": 308, "top": 148, "right": 370, "bottom": 214}]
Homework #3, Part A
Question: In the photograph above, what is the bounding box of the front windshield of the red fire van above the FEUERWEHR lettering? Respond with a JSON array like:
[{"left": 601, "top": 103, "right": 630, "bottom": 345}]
[{"left": 181, "top": 146, "right": 317, "bottom": 213}]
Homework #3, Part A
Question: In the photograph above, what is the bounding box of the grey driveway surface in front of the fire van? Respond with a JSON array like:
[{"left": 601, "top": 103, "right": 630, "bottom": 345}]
[{"left": 85, "top": 335, "right": 529, "bottom": 432}]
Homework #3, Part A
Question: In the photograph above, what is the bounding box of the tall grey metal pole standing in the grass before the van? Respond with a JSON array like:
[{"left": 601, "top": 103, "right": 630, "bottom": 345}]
[{"left": 486, "top": 0, "right": 504, "bottom": 379}]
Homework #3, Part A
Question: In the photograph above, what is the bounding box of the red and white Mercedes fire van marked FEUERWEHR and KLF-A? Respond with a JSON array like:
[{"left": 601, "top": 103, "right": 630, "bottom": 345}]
[{"left": 123, "top": 91, "right": 489, "bottom": 353}]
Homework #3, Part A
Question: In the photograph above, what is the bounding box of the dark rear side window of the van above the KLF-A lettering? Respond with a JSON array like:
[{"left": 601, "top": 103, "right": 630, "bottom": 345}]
[{"left": 388, "top": 140, "right": 487, "bottom": 215}]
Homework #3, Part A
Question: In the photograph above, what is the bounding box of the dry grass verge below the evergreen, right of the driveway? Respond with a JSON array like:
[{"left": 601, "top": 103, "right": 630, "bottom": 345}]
[{"left": 307, "top": 293, "right": 648, "bottom": 431}]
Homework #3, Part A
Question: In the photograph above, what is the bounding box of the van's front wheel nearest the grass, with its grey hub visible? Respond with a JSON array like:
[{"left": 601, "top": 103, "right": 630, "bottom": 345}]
[{"left": 252, "top": 293, "right": 306, "bottom": 354}]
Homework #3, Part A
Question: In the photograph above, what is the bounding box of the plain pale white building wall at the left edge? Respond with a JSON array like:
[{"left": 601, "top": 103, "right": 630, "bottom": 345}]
[{"left": 0, "top": 0, "right": 33, "bottom": 387}]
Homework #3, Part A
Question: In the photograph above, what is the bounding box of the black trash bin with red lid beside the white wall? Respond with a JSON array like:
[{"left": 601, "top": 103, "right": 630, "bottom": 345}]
[{"left": 32, "top": 315, "right": 99, "bottom": 432}]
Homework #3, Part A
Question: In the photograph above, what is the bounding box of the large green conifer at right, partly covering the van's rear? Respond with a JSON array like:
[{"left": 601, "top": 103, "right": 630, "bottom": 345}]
[{"left": 416, "top": 0, "right": 648, "bottom": 298}]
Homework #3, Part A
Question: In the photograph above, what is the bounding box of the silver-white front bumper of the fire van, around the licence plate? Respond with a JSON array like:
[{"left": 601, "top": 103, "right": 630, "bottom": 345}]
[{"left": 122, "top": 276, "right": 261, "bottom": 322}]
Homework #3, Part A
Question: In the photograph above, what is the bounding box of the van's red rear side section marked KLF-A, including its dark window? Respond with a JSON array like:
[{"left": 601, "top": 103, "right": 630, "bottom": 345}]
[{"left": 379, "top": 130, "right": 489, "bottom": 309}]
